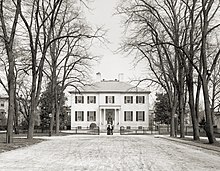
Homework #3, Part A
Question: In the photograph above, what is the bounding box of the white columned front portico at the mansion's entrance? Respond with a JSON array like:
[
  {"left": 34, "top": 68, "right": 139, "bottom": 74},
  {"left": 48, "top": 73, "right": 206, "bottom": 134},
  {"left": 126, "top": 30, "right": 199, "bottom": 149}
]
[{"left": 99, "top": 105, "right": 121, "bottom": 131}]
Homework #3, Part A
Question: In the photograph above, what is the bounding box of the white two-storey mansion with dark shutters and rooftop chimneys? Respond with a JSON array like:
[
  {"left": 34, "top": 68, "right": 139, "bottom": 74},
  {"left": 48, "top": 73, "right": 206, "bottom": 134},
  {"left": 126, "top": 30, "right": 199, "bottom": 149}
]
[{"left": 70, "top": 73, "right": 150, "bottom": 131}]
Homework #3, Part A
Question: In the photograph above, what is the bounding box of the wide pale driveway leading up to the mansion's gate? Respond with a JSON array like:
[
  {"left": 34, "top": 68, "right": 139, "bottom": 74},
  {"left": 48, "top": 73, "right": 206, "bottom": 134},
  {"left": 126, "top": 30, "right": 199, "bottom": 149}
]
[{"left": 0, "top": 134, "right": 220, "bottom": 171}]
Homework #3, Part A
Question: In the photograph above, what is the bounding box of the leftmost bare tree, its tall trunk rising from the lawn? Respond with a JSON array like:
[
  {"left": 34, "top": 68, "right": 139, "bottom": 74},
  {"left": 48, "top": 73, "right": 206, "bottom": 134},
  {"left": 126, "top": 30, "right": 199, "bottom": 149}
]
[{"left": 0, "top": 0, "right": 21, "bottom": 143}]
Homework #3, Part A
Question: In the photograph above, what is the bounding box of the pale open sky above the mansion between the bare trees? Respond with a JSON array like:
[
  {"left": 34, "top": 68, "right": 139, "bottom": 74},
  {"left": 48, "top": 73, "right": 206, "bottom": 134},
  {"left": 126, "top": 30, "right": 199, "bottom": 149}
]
[{"left": 86, "top": 0, "right": 146, "bottom": 81}]
